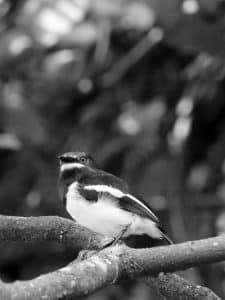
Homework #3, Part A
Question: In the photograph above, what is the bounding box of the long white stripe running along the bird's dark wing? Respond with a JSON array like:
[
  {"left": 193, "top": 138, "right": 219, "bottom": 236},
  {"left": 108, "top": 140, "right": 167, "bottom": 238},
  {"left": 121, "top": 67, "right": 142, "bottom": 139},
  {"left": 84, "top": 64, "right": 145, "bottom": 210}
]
[{"left": 84, "top": 185, "right": 158, "bottom": 221}]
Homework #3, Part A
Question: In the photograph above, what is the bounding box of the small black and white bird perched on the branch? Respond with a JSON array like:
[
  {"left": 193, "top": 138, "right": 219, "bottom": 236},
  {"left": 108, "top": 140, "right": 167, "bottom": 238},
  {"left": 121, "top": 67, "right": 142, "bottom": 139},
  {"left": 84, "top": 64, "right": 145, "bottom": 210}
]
[{"left": 59, "top": 152, "right": 172, "bottom": 244}]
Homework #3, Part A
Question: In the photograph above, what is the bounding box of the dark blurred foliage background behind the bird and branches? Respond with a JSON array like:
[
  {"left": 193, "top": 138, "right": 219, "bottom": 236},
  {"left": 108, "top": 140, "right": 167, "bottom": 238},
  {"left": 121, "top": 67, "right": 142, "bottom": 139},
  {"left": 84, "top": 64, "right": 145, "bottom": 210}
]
[{"left": 0, "top": 0, "right": 225, "bottom": 300}]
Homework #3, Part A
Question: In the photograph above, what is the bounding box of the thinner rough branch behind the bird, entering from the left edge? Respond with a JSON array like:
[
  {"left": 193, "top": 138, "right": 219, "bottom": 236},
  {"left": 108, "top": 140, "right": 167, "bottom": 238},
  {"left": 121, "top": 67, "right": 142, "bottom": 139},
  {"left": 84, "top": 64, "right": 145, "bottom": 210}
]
[{"left": 0, "top": 215, "right": 110, "bottom": 251}]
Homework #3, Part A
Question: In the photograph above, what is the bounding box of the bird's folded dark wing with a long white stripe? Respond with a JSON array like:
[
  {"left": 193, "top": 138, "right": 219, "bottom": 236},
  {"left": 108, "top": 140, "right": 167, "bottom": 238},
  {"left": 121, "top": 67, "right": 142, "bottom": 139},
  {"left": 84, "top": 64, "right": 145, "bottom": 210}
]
[{"left": 82, "top": 184, "right": 159, "bottom": 223}]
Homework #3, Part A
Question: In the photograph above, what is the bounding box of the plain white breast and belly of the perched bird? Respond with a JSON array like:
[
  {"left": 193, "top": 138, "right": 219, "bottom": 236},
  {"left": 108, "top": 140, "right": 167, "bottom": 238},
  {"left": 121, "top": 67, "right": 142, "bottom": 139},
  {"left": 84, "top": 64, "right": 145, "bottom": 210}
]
[{"left": 66, "top": 183, "right": 160, "bottom": 238}]
